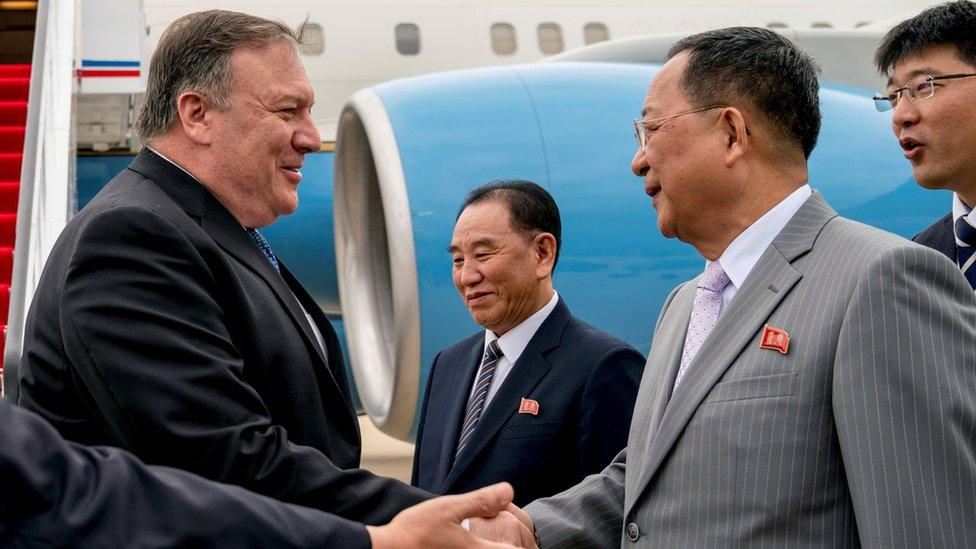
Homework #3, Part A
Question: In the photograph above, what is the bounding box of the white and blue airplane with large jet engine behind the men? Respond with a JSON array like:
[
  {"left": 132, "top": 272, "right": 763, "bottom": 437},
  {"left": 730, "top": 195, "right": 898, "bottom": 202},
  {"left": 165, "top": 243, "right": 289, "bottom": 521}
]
[{"left": 0, "top": 0, "right": 949, "bottom": 450}]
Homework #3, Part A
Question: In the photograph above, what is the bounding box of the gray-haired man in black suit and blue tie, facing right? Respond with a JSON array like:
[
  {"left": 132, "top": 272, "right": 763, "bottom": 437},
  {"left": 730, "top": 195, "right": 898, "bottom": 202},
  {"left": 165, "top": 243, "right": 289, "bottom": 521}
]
[{"left": 13, "top": 7, "right": 430, "bottom": 524}]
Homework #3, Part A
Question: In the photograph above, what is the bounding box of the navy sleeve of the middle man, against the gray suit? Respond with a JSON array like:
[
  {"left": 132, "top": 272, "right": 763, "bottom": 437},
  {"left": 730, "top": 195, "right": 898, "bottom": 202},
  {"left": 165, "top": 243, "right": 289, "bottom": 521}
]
[{"left": 577, "top": 345, "right": 645, "bottom": 477}]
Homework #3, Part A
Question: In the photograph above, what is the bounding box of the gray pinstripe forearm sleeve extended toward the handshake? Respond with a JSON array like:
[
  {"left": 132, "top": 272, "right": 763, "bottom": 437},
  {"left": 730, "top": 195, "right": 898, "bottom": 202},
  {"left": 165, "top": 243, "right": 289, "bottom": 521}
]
[{"left": 525, "top": 448, "right": 627, "bottom": 549}]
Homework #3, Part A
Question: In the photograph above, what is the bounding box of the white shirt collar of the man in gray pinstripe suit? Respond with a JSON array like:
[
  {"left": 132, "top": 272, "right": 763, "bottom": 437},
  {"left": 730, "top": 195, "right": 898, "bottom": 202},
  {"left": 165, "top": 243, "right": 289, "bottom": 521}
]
[{"left": 706, "top": 185, "right": 813, "bottom": 289}]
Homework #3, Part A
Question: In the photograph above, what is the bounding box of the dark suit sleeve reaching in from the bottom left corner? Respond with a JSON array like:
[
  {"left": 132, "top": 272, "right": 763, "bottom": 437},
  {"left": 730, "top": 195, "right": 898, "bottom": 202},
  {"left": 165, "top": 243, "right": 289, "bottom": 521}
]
[{"left": 0, "top": 400, "right": 370, "bottom": 548}]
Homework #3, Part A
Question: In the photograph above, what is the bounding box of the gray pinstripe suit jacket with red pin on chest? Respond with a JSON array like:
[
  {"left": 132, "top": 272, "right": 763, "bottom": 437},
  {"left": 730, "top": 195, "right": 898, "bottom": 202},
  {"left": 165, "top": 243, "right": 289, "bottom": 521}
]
[{"left": 526, "top": 193, "right": 976, "bottom": 549}]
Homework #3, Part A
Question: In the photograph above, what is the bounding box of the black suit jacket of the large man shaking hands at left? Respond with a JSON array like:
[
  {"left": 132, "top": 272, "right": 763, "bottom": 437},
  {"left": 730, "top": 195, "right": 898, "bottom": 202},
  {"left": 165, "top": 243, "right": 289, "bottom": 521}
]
[{"left": 20, "top": 149, "right": 429, "bottom": 524}]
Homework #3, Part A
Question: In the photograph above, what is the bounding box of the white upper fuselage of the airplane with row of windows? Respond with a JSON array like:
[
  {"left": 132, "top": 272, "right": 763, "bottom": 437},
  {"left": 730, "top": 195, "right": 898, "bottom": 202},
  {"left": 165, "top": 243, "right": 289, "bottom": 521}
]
[{"left": 78, "top": 0, "right": 929, "bottom": 144}]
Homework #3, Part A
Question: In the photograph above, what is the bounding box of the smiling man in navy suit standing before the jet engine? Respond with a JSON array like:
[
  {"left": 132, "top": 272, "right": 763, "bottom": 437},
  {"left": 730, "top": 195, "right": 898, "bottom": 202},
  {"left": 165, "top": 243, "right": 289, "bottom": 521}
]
[{"left": 413, "top": 181, "right": 644, "bottom": 503}]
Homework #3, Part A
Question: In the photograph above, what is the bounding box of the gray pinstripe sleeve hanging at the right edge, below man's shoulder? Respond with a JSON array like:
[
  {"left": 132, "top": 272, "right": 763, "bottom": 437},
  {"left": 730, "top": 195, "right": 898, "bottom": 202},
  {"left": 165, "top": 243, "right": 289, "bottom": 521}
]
[{"left": 832, "top": 245, "right": 976, "bottom": 547}]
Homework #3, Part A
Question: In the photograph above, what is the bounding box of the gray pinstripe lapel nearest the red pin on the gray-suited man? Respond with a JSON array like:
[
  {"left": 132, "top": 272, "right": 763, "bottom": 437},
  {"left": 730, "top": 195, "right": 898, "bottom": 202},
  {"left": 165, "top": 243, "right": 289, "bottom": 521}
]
[{"left": 625, "top": 193, "right": 837, "bottom": 516}]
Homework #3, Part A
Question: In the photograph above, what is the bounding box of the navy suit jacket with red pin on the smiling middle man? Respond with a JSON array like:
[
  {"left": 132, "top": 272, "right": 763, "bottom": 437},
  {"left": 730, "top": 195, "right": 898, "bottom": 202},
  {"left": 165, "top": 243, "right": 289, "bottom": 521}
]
[{"left": 413, "top": 298, "right": 645, "bottom": 505}]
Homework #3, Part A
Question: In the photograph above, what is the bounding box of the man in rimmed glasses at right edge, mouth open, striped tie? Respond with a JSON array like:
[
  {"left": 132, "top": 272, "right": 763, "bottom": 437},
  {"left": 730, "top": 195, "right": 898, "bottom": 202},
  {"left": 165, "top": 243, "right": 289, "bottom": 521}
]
[{"left": 875, "top": 1, "right": 976, "bottom": 288}]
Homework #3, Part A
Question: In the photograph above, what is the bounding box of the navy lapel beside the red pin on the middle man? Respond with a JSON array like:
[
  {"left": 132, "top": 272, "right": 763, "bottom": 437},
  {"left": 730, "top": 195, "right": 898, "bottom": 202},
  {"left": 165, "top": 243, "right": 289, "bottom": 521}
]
[{"left": 443, "top": 298, "right": 570, "bottom": 492}]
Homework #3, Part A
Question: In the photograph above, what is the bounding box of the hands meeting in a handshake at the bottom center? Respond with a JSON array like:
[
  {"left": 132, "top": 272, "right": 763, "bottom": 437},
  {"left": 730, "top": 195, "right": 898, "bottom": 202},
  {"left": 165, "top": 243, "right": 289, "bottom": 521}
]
[{"left": 366, "top": 482, "right": 536, "bottom": 549}]
